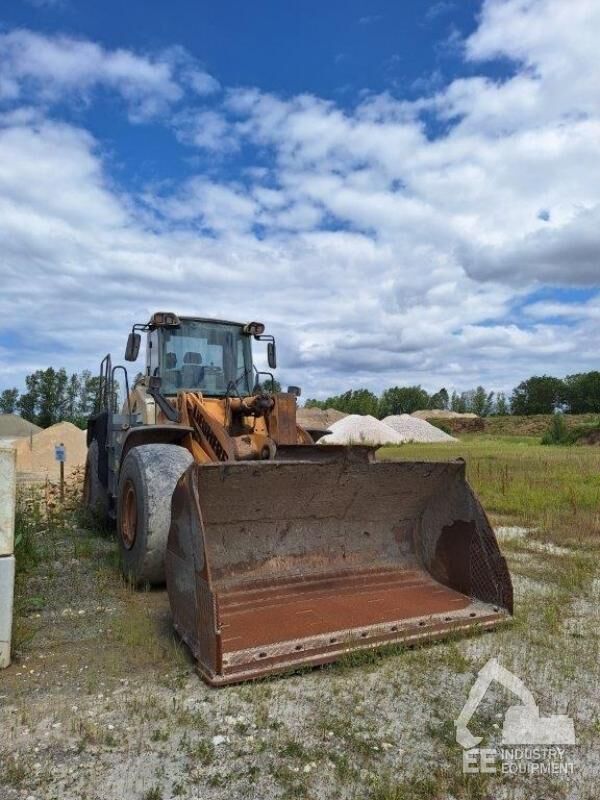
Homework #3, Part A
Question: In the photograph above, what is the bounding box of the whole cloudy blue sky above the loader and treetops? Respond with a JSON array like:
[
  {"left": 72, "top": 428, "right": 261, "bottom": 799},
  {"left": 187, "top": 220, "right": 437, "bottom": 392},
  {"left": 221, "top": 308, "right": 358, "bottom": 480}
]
[{"left": 0, "top": 0, "right": 600, "bottom": 397}]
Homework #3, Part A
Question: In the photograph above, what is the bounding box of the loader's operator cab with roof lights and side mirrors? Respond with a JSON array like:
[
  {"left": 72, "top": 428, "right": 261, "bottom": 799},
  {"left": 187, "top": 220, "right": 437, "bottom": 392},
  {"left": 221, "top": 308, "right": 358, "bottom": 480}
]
[{"left": 125, "top": 312, "right": 276, "bottom": 397}]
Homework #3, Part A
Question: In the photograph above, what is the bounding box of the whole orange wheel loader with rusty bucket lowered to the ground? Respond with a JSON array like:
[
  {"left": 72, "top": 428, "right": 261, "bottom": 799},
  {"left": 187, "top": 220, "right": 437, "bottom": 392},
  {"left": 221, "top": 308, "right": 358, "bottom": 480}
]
[{"left": 84, "top": 312, "right": 512, "bottom": 685}]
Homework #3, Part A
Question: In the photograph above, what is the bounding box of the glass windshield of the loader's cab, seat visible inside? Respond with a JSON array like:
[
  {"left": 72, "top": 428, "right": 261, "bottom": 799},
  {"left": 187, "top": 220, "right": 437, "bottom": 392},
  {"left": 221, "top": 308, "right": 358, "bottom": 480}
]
[{"left": 159, "top": 319, "right": 253, "bottom": 396}]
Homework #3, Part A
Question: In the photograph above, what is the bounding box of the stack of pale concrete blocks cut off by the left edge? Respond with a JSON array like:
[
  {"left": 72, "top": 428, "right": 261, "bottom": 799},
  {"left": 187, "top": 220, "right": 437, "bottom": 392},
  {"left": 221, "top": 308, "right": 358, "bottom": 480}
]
[{"left": 0, "top": 446, "right": 17, "bottom": 669}]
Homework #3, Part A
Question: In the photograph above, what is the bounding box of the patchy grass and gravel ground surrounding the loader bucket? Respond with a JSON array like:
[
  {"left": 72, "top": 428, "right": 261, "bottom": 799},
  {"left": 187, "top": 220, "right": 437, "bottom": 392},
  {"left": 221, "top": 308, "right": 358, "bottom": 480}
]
[{"left": 0, "top": 435, "right": 600, "bottom": 800}]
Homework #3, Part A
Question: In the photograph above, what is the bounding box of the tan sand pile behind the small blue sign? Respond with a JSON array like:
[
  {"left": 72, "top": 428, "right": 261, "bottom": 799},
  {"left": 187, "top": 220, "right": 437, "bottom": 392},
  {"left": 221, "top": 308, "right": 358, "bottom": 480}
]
[{"left": 15, "top": 422, "right": 87, "bottom": 480}]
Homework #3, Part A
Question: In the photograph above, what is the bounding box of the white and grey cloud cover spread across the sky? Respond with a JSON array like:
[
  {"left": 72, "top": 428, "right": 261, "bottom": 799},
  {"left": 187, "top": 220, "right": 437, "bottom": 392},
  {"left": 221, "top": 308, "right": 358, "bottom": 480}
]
[{"left": 0, "top": 0, "right": 600, "bottom": 395}]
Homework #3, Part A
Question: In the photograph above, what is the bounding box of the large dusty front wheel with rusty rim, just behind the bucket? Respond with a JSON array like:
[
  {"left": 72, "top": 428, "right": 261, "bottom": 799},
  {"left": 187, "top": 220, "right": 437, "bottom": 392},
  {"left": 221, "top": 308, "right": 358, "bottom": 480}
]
[{"left": 117, "top": 444, "right": 194, "bottom": 586}]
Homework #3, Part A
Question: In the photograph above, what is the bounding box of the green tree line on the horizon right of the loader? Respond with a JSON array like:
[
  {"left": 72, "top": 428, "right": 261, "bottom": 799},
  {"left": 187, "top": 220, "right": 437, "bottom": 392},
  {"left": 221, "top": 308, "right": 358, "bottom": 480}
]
[{"left": 306, "top": 371, "right": 600, "bottom": 419}]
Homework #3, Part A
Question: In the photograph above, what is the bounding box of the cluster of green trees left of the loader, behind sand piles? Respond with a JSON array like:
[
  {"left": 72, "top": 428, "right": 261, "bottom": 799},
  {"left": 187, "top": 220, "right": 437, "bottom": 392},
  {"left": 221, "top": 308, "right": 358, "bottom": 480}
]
[{"left": 0, "top": 367, "right": 100, "bottom": 428}]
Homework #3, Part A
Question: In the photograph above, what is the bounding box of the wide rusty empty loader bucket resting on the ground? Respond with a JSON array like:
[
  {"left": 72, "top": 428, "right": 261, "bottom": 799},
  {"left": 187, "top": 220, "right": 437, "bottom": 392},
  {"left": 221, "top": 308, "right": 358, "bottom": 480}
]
[{"left": 166, "top": 448, "right": 512, "bottom": 685}]
